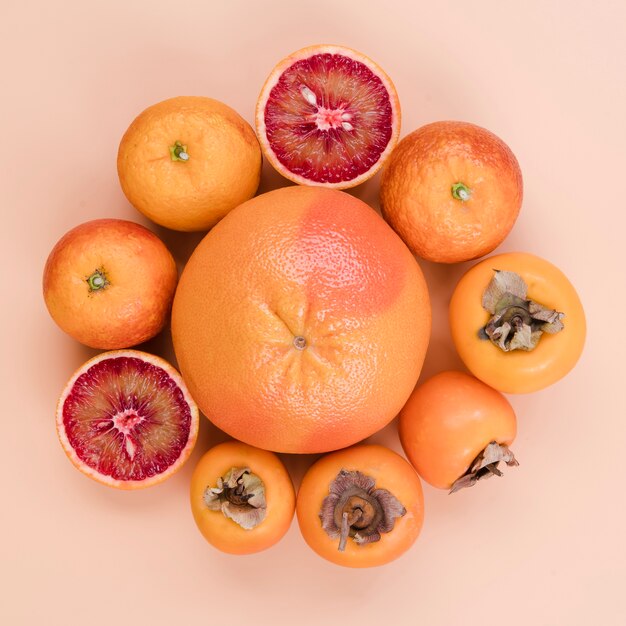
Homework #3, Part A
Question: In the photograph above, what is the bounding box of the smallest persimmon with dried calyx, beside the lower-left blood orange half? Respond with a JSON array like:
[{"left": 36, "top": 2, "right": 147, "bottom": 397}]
[{"left": 190, "top": 441, "right": 296, "bottom": 554}]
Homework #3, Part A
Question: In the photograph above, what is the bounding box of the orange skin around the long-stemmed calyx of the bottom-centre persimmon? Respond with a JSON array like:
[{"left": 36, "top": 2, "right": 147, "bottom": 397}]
[{"left": 296, "top": 445, "right": 424, "bottom": 567}]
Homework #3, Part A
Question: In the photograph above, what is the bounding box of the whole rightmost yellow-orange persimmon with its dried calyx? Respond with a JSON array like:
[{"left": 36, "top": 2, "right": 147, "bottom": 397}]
[{"left": 450, "top": 252, "right": 586, "bottom": 393}]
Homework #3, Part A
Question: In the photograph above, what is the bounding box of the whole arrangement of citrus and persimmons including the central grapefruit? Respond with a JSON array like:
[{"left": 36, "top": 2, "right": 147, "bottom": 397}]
[{"left": 43, "top": 45, "right": 585, "bottom": 567}]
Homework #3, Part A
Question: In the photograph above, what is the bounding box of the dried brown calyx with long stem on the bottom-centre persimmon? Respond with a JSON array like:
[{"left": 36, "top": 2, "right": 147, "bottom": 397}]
[{"left": 319, "top": 469, "right": 406, "bottom": 552}]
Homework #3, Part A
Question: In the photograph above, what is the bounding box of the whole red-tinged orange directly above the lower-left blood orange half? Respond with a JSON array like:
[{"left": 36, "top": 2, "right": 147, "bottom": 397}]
[{"left": 43, "top": 219, "right": 178, "bottom": 350}]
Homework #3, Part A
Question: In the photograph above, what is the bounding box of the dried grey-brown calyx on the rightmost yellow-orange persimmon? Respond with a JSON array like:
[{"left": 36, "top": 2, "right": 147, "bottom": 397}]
[{"left": 479, "top": 270, "right": 565, "bottom": 352}]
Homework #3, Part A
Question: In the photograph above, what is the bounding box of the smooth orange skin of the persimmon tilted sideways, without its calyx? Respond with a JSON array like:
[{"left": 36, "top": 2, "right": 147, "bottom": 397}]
[{"left": 399, "top": 371, "right": 517, "bottom": 489}]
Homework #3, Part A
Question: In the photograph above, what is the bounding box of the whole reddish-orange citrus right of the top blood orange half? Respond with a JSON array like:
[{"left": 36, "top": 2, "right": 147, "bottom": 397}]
[{"left": 380, "top": 122, "right": 522, "bottom": 263}]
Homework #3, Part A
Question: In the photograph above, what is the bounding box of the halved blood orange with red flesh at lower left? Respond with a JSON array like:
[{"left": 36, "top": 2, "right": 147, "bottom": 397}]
[{"left": 57, "top": 350, "right": 198, "bottom": 489}]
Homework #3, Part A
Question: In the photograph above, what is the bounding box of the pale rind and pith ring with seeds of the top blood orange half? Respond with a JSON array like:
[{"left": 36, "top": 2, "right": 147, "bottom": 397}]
[{"left": 255, "top": 45, "right": 401, "bottom": 189}]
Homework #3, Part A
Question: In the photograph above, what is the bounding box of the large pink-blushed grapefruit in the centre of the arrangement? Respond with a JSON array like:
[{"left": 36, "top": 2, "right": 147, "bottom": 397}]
[{"left": 172, "top": 186, "right": 431, "bottom": 453}]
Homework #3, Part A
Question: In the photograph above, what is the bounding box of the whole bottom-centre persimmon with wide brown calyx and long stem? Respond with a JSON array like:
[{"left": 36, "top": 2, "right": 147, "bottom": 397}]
[{"left": 296, "top": 445, "right": 424, "bottom": 567}]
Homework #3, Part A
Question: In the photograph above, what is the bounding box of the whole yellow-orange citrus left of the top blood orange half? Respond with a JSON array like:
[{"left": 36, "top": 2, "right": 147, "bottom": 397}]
[{"left": 117, "top": 96, "right": 261, "bottom": 231}]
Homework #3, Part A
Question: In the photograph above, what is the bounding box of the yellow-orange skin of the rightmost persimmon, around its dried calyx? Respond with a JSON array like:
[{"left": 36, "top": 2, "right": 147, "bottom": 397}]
[{"left": 450, "top": 252, "right": 586, "bottom": 393}]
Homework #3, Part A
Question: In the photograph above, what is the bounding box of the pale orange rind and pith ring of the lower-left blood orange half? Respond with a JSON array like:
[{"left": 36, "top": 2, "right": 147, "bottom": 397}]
[{"left": 56, "top": 350, "right": 200, "bottom": 489}]
